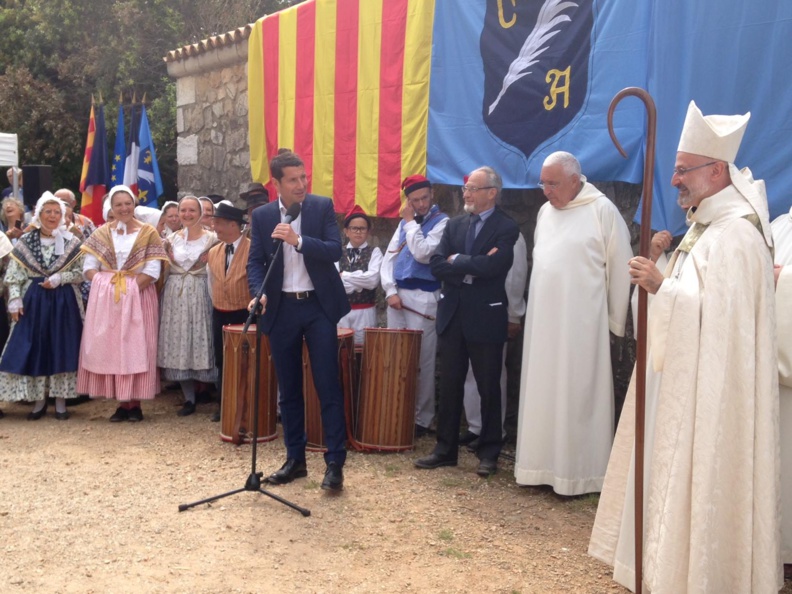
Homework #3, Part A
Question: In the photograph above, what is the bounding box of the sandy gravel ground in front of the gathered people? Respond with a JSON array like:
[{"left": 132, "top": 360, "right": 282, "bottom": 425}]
[{"left": 0, "top": 393, "right": 792, "bottom": 594}]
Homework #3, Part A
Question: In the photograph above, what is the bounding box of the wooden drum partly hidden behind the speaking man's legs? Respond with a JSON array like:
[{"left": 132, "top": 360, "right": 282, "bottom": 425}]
[{"left": 303, "top": 328, "right": 355, "bottom": 452}]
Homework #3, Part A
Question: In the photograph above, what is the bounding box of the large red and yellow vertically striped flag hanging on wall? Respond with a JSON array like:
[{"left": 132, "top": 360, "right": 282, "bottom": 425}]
[{"left": 248, "top": 0, "right": 434, "bottom": 217}]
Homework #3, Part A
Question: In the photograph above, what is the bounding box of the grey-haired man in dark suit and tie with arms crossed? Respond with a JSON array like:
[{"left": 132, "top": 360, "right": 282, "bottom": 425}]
[{"left": 415, "top": 167, "right": 520, "bottom": 477}]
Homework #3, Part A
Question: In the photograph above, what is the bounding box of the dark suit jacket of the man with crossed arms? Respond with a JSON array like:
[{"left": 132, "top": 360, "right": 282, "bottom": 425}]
[{"left": 431, "top": 207, "right": 520, "bottom": 342}]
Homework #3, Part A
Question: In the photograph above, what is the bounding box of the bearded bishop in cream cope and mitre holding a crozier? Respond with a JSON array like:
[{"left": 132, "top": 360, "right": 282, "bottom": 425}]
[{"left": 589, "top": 102, "right": 783, "bottom": 594}]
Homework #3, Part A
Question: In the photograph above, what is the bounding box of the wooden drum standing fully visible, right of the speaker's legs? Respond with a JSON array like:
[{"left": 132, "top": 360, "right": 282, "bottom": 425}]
[{"left": 354, "top": 328, "right": 423, "bottom": 452}]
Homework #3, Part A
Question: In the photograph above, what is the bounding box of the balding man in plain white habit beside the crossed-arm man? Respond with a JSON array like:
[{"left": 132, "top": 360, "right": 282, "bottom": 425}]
[{"left": 514, "top": 152, "right": 633, "bottom": 495}]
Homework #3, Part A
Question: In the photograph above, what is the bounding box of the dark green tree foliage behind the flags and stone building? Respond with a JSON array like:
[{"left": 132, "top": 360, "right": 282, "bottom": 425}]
[{"left": 0, "top": 0, "right": 301, "bottom": 202}]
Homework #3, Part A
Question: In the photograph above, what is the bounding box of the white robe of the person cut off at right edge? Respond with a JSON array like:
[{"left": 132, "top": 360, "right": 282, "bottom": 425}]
[{"left": 772, "top": 210, "right": 792, "bottom": 563}]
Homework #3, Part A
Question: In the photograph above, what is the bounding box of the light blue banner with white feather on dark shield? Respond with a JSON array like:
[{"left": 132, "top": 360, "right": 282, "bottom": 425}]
[{"left": 427, "top": 0, "right": 792, "bottom": 234}]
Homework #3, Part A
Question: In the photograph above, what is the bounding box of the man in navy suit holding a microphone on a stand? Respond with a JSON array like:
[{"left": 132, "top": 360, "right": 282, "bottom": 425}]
[{"left": 247, "top": 151, "right": 350, "bottom": 491}]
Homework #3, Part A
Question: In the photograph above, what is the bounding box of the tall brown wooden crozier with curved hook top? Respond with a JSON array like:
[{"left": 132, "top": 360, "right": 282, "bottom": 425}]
[{"left": 608, "top": 87, "right": 657, "bottom": 594}]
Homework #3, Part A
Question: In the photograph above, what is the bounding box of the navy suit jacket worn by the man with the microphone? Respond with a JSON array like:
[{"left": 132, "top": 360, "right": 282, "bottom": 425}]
[{"left": 247, "top": 194, "right": 350, "bottom": 334}]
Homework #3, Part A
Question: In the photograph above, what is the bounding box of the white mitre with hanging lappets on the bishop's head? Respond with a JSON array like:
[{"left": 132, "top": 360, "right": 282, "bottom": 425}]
[{"left": 677, "top": 101, "right": 773, "bottom": 247}]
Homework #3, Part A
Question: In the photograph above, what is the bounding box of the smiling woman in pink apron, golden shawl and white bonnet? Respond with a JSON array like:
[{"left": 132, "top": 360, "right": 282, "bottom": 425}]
[{"left": 77, "top": 186, "right": 168, "bottom": 423}]
